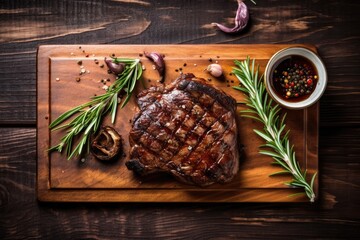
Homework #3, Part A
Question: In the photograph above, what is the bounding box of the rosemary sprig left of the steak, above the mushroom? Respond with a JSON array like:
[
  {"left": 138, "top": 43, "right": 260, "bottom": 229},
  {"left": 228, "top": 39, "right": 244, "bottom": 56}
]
[{"left": 49, "top": 58, "right": 142, "bottom": 159}]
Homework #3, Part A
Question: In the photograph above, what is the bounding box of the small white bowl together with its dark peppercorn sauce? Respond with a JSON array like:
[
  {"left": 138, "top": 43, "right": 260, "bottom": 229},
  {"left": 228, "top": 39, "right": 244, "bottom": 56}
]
[{"left": 264, "top": 47, "right": 327, "bottom": 109}]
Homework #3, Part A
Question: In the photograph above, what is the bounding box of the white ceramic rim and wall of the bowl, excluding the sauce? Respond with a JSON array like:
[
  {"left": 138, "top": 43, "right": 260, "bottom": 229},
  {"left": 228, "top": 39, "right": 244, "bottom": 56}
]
[{"left": 264, "top": 47, "right": 327, "bottom": 109}]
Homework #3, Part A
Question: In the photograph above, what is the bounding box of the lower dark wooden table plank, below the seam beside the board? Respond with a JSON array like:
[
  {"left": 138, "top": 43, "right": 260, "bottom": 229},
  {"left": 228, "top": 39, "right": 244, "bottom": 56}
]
[{"left": 0, "top": 128, "right": 360, "bottom": 239}]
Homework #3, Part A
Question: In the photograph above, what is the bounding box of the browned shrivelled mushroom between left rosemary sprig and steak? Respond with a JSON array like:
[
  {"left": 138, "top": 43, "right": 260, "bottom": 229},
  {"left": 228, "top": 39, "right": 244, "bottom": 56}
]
[{"left": 91, "top": 126, "right": 122, "bottom": 161}]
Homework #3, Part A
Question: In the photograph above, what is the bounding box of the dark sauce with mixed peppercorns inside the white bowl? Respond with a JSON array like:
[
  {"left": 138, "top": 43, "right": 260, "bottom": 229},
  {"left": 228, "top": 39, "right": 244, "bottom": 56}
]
[{"left": 272, "top": 55, "right": 318, "bottom": 101}]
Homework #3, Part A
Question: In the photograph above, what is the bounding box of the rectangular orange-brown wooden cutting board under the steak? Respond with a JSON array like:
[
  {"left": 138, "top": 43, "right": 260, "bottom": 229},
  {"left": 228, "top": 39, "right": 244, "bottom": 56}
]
[{"left": 37, "top": 44, "right": 318, "bottom": 202}]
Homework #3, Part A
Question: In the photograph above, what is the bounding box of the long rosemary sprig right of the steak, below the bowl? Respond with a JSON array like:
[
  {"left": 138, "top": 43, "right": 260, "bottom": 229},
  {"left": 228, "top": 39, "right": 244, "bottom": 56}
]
[{"left": 233, "top": 57, "right": 317, "bottom": 202}]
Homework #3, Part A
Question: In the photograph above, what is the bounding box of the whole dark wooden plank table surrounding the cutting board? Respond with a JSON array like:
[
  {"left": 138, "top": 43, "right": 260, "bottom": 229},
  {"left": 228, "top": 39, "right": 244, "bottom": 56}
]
[{"left": 0, "top": 0, "right": 360, "bottom": 239}]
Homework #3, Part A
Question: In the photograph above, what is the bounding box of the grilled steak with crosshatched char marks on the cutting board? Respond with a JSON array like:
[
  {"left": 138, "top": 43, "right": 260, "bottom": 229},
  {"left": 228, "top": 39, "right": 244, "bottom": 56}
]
[{"left": 126, "top": 74, "right": 239, "bottom": 186}]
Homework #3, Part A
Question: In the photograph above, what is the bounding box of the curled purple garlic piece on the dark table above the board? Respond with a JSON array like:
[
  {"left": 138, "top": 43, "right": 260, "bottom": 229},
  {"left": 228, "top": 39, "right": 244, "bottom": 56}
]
[{"left": 212, "top": 0, "right": 249, "bottom": 33}]
